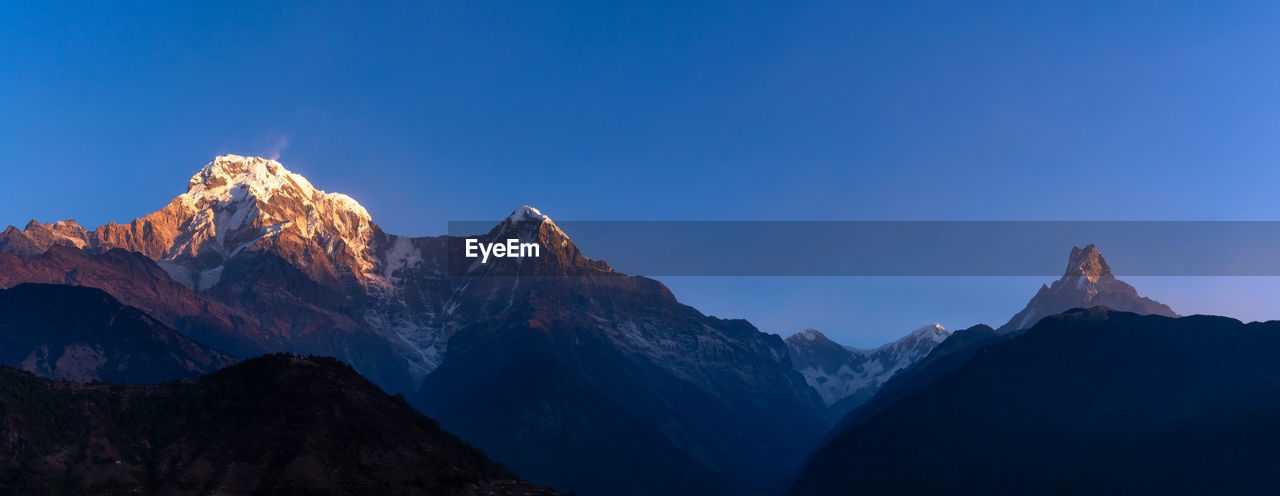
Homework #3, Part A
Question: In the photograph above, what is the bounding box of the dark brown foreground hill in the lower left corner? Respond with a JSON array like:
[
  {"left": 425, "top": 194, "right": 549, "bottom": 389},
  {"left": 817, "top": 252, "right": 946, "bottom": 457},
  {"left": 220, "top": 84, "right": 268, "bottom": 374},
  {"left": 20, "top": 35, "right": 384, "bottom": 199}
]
[{"left": 0, "top": 354, "right": 552, "bottom": 495}]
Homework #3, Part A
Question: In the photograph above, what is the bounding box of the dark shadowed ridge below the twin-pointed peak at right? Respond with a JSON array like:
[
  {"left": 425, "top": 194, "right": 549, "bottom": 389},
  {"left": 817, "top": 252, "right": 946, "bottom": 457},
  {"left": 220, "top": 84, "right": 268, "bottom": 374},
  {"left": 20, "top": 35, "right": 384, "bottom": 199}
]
[{"left": 790, "top": 307, "right": 1280, "bottom": 495}]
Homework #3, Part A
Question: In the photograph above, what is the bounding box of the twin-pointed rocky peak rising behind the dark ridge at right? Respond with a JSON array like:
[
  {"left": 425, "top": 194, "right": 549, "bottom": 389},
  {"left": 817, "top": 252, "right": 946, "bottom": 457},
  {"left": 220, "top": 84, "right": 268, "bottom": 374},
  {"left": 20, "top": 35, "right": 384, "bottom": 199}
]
[{"left": 996, "top": 244, "right": 1178, "bottom": 334}]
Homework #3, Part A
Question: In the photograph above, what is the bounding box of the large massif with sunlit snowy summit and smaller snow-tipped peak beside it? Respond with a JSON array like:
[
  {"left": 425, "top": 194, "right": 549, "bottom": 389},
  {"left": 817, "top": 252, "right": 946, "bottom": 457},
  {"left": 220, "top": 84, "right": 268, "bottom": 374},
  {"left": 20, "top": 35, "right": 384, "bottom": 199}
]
[{"left": 0, "top": 155, "right": 829, "bottom": 493}]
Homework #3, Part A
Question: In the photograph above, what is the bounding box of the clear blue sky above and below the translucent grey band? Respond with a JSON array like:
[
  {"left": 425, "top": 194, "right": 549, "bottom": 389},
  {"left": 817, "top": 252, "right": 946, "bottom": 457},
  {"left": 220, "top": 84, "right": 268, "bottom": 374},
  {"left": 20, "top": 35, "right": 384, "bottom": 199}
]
[{"left": 0, "top": 1, "right": 1280, "bottom": 345}]
